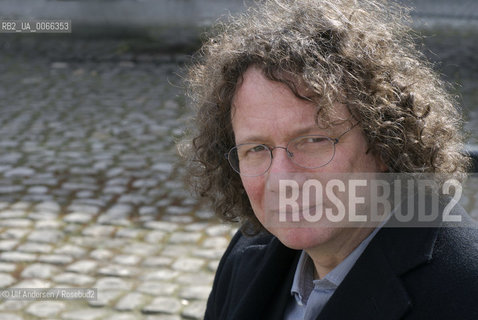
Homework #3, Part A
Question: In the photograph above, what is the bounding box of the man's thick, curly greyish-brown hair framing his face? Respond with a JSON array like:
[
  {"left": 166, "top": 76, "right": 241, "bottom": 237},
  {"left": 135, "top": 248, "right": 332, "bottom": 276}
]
[{"left": 183, "top": 0, "right": 469, "bottom": 233}]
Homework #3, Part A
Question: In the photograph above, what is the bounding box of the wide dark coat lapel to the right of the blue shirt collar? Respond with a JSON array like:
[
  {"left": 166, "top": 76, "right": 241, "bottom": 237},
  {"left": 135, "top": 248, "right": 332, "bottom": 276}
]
[{"left": 317, "top": 228, "right": 438, "bottom": 320}]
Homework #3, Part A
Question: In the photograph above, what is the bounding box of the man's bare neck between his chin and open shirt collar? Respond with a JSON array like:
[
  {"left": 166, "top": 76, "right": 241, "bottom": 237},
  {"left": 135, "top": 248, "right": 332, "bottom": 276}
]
[{"left": 305, "top": 228, "right": 374, "bottom": 279}]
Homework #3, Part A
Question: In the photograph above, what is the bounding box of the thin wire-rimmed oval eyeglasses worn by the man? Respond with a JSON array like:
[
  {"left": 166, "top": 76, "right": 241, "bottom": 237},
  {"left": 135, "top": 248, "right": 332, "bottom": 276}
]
[{"left": 224, "top": 123, "right": 358, "bottom": 177}]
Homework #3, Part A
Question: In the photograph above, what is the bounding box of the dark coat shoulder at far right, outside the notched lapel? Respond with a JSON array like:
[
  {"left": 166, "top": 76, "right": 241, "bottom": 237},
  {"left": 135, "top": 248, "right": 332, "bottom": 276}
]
[{"left": 403, "top": 211, "right": 478, "bottom": 320}]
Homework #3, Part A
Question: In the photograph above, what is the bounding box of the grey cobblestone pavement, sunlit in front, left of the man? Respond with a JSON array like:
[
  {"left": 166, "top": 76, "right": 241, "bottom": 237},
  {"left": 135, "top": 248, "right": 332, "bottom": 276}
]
[{"left": 0, "top": 37, "right": 239, "bottom": 320}]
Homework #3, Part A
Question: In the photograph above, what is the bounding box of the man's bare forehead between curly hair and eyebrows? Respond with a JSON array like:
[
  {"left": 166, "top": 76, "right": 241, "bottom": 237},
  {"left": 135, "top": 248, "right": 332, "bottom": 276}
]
[{"left": 231, "top": 67, "right": 348, "bottom": 143}]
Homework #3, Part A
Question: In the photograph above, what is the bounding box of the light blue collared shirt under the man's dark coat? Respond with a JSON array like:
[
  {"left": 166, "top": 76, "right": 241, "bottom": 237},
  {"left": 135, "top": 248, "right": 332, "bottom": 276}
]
[{"left": 284, "top": 228, "right": 380, "bottom": 320}]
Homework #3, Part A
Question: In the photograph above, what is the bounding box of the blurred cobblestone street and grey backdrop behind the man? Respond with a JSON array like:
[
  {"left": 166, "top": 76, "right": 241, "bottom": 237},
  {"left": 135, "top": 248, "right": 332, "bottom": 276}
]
[{"left": 0, "top": 0, "right": 478, "bottom": 320}]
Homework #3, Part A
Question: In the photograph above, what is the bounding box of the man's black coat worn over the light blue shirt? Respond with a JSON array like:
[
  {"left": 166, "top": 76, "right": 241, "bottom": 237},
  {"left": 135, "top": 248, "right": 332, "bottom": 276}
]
[{"left": 205, "top": 209, "right": 478, "bottom": 320}]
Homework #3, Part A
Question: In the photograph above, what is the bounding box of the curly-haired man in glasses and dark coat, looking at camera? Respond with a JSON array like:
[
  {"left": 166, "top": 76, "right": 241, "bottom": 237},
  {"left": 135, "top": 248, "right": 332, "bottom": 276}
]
[{"left": 184, "top": 0, "right": 478, "bottom": 319}]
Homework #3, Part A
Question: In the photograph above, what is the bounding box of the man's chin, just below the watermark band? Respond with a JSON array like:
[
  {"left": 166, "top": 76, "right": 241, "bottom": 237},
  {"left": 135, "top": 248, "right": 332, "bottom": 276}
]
[{"left": 269, "top": 227, "right": 338, "bottom": 250}]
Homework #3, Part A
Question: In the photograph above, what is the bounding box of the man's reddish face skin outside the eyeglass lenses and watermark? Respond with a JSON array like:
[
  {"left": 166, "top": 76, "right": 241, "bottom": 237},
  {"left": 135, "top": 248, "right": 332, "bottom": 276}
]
[{"left": 232, "top": 67, "right": 385, "bottom": 249}]
